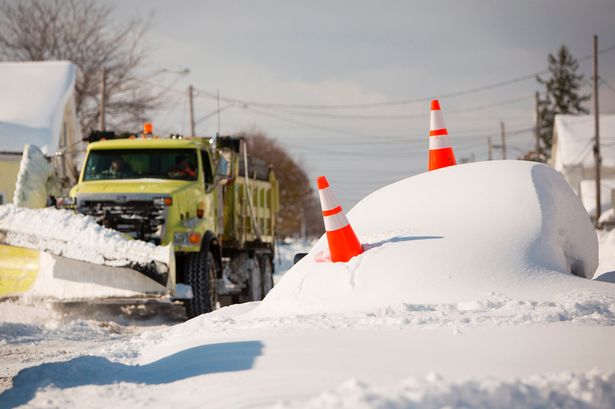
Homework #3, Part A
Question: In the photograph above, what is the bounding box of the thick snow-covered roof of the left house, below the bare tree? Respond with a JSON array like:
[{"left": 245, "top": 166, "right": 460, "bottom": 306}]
[{"left": 0, "top": 61, "right": 77, "bottom": 153}]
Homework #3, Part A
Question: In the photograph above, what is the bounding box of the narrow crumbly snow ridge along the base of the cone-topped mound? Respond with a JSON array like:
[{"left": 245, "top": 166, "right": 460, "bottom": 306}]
[{"left": 105, "top": 295, "right": 615, "bottom": 363}]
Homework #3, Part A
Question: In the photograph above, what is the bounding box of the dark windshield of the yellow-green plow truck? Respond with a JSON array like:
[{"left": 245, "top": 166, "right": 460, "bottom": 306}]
[{"left": 83, "top": 149, "right": 198, "bottom": 180}]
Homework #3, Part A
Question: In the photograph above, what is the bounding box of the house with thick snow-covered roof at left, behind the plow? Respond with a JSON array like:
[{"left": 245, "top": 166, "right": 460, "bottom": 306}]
[{"left": 0, "top": 61, "right": 81, "bottom": 204}]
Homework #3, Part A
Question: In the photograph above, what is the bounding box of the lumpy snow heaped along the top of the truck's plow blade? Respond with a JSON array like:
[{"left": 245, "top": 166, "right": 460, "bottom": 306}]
[{"left": 0, "top": 205, "right": 170, "bottom": 267}]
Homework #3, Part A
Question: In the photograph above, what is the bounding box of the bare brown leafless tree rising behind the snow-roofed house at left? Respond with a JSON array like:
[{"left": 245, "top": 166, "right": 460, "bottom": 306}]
[{"left": 0, "top": 0, "right": 163, "bottom": 132}]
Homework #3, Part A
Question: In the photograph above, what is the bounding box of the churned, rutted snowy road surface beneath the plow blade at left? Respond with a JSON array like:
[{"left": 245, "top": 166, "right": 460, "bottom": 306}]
[{"left": 0, "top": 301, "right": 183, "bottom": 393}]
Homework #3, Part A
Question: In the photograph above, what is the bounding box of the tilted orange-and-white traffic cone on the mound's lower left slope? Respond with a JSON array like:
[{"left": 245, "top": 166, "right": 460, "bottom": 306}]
[{"left": 317, "top": 176, "right": 363, "bottom": 262}]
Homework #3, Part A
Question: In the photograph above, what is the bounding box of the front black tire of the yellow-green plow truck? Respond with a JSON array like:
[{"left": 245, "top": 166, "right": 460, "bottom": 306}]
[{"left": 184, "top": 250, "right": 218, "bottom": 318}]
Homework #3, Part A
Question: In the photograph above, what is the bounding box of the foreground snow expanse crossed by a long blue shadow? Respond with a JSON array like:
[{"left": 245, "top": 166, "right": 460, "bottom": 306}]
[{"left": 0, "top": 304, "right": 615, "bottom": 408}]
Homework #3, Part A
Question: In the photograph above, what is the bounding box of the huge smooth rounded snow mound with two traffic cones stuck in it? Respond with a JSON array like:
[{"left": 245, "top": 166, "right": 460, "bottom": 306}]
[{"left": 252, "top": 161, "right": 615, "bottom": 316}]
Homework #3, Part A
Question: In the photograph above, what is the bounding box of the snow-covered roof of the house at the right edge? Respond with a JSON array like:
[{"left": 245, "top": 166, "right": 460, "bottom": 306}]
[{"left": 553, "top": 114, "right": 615, "bottom": 172}]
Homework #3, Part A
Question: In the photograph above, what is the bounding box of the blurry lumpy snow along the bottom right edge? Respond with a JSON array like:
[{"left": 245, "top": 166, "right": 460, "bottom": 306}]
[{"left": 275, "top": 371, "right": 615, "bottom": 409}]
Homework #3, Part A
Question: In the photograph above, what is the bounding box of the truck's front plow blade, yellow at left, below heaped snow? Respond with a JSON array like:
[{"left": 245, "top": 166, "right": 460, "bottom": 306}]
[{"left": 0, "top": 229, "right": 175, "bottom": 301}]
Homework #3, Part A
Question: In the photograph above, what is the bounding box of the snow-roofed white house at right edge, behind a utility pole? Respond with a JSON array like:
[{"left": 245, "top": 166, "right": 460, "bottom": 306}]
[{"left": 549, "top": 114, "right": 615, "bottom": 216}]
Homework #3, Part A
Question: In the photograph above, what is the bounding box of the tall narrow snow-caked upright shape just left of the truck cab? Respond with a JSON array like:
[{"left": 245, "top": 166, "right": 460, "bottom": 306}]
[{"left": 13, "top": 145, "right": 59, "bottom": 209}]
